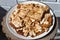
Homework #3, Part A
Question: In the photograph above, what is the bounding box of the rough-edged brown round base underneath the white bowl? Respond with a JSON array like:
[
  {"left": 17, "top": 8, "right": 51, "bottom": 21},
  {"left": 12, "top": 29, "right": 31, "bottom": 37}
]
[{"left": 2, "top": 17, "right": 57, "bottom": 40}]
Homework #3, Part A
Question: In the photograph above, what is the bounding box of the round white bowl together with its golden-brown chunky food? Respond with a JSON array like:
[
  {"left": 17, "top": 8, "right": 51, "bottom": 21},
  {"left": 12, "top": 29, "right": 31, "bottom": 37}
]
[{"left": 6, "top": 1, "right": 55, "bottom": 39}]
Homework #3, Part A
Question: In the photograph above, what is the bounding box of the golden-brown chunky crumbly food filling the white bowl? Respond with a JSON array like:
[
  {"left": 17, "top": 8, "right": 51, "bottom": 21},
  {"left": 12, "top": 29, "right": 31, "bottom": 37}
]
[{"left": 9, "top": 3, "right": 52, "bottom": 37}]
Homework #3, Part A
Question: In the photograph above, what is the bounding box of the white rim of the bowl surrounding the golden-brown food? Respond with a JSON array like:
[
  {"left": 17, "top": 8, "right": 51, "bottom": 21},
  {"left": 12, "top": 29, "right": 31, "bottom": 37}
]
[{"left": 6, "top": 1, "right": 55, "bottom": 39}]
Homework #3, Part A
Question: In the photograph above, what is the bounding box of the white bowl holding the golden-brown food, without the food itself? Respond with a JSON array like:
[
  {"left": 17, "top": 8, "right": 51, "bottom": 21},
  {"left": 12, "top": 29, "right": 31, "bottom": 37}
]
[{"left": 6, "top": 1, "right": 55, "bottom": 39}]
